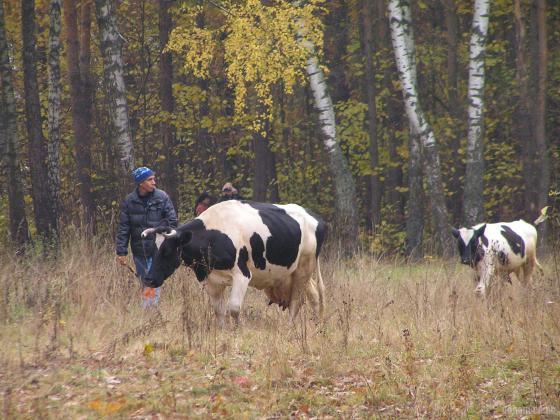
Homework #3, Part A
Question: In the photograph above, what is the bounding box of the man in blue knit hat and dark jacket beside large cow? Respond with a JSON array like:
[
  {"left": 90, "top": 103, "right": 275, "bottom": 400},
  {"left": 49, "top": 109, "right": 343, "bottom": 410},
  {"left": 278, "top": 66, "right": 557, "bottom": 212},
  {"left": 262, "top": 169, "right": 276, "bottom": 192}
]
[{"left": 116, "top": 166, "right": 177, "bottom": 307}]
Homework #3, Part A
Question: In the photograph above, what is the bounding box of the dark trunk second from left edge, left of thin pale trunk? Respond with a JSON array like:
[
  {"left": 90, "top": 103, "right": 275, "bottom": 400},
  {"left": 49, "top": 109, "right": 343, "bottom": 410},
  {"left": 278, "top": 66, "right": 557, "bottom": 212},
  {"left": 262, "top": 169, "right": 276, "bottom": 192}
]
[{"left": 21, "top": 0, "right": 55, "bottom": 237}]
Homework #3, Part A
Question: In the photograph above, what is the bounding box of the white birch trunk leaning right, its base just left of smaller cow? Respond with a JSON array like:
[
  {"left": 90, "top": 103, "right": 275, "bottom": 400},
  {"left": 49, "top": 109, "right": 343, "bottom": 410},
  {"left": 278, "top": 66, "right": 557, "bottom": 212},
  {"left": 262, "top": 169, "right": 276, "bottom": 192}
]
[{"left": 389, "top": 0, "right": 452, "bottom": 255}]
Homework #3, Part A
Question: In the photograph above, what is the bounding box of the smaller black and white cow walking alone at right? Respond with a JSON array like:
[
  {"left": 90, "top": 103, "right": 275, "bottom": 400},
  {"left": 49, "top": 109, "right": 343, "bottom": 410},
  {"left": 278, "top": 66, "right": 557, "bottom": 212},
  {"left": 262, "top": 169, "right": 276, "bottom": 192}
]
[{"left": 452, "top": 220, "right": 540, "bottom": 295}]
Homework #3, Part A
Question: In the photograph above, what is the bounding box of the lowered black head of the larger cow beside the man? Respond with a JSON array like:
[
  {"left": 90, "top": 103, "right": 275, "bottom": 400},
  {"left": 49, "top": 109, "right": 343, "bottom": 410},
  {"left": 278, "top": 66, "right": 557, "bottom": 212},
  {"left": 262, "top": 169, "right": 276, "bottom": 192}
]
[{"left": 142, "top": 229, "right": 192, "bottom": 287}]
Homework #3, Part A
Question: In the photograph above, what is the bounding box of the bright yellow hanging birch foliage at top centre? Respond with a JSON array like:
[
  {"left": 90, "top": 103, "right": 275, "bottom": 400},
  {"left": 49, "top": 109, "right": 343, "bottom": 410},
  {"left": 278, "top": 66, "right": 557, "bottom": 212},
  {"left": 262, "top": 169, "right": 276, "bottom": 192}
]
[{"left": 167, "top": 0, "right": 324, "bottom": 127}]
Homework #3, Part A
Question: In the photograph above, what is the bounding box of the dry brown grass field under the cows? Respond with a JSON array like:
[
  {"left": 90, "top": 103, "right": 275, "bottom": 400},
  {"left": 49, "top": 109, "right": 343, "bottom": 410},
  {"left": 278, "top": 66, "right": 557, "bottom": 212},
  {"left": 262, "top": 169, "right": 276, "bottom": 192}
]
[{"left": 0, "top": 235, "right": 560, "bottom": 419}]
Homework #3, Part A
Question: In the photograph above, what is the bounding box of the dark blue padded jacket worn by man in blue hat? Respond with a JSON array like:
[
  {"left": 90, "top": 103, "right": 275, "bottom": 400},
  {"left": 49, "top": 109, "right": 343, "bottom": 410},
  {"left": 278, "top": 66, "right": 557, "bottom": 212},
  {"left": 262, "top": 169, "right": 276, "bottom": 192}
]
[{"left": 116, "top": 188, "right": 177, "bottom": 257}]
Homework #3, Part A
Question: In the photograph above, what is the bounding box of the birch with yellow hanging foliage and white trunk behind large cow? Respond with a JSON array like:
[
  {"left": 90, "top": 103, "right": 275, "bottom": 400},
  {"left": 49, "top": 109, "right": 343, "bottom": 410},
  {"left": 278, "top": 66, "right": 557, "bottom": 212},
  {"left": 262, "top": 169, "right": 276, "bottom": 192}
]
[{"left": 168, "top": 0, "right": 358, "bottom": 253}]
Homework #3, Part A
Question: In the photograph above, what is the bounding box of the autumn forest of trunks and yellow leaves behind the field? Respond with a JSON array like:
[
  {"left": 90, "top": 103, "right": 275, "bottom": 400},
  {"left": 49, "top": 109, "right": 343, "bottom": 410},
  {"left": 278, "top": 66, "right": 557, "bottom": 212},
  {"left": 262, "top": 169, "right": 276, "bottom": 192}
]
[{"left": 0, "top": 0, "right": 560, "bottom": 255}]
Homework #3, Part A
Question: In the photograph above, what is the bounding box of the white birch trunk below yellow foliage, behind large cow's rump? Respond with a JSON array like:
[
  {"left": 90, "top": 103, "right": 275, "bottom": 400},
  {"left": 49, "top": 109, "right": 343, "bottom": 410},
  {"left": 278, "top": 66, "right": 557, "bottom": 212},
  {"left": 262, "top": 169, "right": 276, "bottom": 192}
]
[{"left": 298, "top": 28, "right": 358, "bottom": 254}]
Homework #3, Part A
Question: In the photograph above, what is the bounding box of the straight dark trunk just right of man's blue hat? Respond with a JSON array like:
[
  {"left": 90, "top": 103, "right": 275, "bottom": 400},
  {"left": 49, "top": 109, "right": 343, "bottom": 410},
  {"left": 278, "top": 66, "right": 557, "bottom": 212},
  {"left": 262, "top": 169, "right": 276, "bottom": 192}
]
[{"left": 158, "top": 0, "right": 179, "bottom": 203}]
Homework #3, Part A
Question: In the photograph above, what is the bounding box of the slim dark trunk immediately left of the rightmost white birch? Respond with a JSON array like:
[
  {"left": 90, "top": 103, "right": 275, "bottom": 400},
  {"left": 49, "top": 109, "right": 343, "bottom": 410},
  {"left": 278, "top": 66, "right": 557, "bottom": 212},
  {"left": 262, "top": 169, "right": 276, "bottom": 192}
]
[{"left": 443, "top": 0, "right": 464, "bottom": 221}]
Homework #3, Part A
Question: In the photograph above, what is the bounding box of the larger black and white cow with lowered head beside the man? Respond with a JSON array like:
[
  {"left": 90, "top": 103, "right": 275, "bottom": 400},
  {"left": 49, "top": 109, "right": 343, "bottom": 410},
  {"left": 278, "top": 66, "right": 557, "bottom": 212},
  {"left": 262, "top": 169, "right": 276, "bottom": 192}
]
[{"left": 139, "top": 200, "right": 326, "bottom": 324}]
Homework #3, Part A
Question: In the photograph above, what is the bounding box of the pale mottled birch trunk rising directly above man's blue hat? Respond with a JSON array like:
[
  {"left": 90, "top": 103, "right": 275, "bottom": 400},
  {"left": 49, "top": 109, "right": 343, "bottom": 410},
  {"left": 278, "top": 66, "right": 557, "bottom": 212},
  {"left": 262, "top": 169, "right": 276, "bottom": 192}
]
[{"left": 95, "top": 0, "right": 134, "bottom": 173}]
